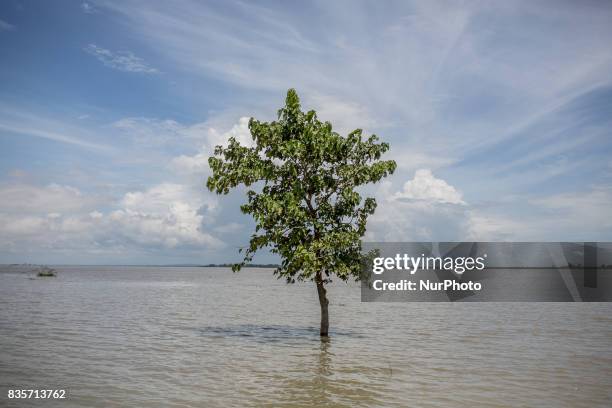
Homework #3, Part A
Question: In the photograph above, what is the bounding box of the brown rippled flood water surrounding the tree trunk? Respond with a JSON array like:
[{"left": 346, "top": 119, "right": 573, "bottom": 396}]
[{"left": 0, "top": 267, "right": 612, "bottom": 408}]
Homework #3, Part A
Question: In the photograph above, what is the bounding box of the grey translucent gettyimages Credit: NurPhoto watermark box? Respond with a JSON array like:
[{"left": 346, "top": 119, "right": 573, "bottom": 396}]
[{"left": 361, "top": 242, "right": 612, "bottom": 302}]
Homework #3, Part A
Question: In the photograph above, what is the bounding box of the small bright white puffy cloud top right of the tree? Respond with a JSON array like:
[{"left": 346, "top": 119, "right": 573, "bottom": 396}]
[{"left": 394, "top": 169, "right": 465, "bottom": 205}]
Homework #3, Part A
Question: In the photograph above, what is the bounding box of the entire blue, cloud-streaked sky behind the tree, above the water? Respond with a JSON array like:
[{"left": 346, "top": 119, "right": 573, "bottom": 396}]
[{"left": 0, "top": 0, "right": 612, "bottom": 264}]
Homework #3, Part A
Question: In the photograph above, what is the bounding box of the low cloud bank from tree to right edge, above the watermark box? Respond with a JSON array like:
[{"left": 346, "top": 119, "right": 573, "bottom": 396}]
[{"left": 366, "top": 170, "right": 612, "bottom": 241}]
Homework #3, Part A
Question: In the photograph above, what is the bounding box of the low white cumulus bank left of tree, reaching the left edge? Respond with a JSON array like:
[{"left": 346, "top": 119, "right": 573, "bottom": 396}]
[{"left": 0, "top": 183, "right": 224, "bottom": 252}]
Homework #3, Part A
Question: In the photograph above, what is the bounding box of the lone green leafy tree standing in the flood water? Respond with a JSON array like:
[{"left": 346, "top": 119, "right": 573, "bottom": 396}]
[{"left": 206, "top": 89, "right": 396, "bottom": 336}]
